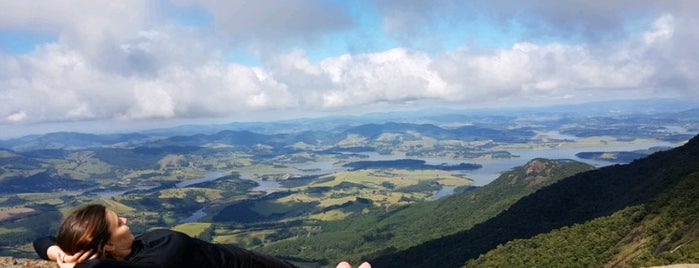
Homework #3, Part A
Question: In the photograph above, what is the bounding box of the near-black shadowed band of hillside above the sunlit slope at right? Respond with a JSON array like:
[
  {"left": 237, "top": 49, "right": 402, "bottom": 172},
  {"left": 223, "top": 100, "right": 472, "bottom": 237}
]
[{"left": 369, "top": 136, "right": 699, "bottom": 267}]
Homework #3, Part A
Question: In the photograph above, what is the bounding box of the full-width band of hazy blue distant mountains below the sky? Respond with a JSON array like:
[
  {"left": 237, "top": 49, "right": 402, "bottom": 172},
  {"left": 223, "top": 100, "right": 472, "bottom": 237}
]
[{"left": 0, "top": 103, "right": 699, "bottom": 152}]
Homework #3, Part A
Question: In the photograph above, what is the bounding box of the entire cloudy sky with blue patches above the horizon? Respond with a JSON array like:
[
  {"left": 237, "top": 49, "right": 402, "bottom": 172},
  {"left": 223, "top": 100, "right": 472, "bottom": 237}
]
[{"left": 0, "top": 0, "right": 699, "bottom": 138}]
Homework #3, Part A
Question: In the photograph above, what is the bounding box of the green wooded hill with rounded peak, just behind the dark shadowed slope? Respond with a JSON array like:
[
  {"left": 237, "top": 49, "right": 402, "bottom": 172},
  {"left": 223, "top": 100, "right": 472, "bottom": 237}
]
[{"left": 262, "top": 159, "right": 593, "bottom": 267}]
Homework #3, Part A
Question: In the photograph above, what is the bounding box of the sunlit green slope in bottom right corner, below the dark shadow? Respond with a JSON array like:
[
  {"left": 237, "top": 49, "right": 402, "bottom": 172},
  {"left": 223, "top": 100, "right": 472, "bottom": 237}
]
[{"left": 466, "top": 173, "right": 699, "bottom": 267}]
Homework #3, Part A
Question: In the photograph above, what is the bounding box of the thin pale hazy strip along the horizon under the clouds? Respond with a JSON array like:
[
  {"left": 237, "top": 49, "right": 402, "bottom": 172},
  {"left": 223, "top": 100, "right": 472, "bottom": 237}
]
[{"left": 0, "top": 99, "right": 699, "bottom": 141}]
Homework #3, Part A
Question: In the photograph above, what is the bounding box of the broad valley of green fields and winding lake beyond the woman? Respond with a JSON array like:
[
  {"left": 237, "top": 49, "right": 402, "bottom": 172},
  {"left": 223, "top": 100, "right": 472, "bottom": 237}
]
[{"left": 0, "top": 102, "right": 699, "bottom": 267}]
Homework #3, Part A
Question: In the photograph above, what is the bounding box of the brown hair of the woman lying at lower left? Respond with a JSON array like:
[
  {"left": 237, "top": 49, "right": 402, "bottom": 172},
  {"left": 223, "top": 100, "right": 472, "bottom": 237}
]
[{"left": 56, "top": 204, "right": 111, "bottom": 258}]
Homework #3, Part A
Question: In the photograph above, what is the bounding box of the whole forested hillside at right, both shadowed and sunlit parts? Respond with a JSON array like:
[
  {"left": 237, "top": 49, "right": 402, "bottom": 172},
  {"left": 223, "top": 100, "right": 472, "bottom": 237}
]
[{"left": 373, "top": 137, "right": 699, "bottom": 267}]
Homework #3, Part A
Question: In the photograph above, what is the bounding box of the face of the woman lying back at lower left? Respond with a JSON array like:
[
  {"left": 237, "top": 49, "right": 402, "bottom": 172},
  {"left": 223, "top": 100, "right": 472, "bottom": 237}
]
[{"left": 105, "top": 209, "right": 134, "bottom": 259}]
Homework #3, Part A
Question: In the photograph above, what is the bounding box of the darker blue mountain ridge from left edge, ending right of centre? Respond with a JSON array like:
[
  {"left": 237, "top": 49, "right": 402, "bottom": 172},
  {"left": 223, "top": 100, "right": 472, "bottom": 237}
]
[{"left": 0, "top": 122, "right": 535, "bottom": 152}]
